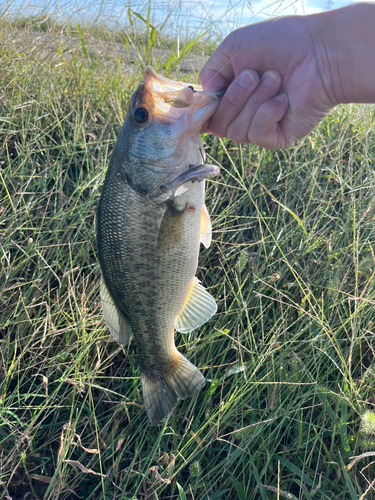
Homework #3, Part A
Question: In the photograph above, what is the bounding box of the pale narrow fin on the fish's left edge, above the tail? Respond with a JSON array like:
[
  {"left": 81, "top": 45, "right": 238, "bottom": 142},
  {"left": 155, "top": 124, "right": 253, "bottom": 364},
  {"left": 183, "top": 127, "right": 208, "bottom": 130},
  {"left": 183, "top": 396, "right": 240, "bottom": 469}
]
[{"left": 100, "top": 276, "right": 131, "bottom": 344}]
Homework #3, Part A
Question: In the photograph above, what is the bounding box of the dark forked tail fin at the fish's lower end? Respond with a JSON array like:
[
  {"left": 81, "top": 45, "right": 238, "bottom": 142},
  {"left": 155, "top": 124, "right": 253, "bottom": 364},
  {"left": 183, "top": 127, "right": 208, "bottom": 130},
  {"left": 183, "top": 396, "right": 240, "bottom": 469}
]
[{"left": 141, "top": 353, "right": 205, "bottom": 425}]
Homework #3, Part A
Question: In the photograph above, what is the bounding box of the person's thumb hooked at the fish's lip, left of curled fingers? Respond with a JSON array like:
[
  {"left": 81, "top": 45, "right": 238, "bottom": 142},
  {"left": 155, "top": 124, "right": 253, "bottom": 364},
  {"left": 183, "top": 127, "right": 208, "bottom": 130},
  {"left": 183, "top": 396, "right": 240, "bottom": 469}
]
[{"left": 199, "top": 40, "right": 235, "bottom": 91}]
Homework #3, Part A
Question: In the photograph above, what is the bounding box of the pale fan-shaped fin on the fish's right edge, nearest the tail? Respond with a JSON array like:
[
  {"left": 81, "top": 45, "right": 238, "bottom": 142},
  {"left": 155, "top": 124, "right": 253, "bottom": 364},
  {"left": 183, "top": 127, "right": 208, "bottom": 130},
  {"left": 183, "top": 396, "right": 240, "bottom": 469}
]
[{"left": 175, "top": 276, "right": 217, "bottom": 333}]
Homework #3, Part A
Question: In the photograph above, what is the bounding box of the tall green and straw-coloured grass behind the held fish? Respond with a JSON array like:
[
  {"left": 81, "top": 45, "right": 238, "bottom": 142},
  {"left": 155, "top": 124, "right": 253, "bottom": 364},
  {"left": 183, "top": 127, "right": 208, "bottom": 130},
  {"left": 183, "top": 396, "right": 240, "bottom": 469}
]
[{"left": 0, "top": 4, "right": 375, "bottom": 500}]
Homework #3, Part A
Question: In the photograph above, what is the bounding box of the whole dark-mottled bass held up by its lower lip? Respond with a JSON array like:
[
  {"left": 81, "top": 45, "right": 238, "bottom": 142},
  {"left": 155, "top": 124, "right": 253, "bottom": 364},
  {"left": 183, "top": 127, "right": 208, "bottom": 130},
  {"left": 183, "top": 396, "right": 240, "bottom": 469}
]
[{"left": 96, "top": 67, "right": 221, "bottom": 425}]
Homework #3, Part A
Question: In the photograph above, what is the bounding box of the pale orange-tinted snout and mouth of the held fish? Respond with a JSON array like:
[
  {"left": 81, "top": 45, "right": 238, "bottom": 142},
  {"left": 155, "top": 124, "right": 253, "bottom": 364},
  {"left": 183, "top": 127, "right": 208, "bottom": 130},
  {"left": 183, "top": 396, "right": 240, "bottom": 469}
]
[{"left": 132, "top": 66, "right": 225, "bottom": 135}]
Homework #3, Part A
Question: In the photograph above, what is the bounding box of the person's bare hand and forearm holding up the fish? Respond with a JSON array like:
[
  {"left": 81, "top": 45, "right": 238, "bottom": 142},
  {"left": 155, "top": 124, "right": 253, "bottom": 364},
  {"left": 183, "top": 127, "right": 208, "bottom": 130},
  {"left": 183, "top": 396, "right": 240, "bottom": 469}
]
[{"left": 199, "top": 3, "right": 375, "bottom": 149}]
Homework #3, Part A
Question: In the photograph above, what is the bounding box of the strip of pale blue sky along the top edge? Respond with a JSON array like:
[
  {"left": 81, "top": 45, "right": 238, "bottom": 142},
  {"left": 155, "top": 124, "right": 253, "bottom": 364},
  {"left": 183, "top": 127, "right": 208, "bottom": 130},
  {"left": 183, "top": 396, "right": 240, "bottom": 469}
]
[{"left": 8, "top": 0, "right": 362, "bottom": 37}]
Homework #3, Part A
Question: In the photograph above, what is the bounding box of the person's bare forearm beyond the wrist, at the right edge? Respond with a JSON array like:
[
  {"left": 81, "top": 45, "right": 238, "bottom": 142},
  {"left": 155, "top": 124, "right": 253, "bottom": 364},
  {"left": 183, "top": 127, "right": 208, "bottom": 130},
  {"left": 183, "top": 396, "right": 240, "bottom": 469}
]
[{"left": 306, "top": 3, "right": 375, "bottom": 104}]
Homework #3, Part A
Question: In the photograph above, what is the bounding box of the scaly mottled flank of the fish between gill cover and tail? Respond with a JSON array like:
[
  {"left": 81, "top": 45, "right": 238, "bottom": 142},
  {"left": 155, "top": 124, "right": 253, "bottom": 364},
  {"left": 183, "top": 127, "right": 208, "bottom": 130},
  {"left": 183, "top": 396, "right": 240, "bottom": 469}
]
[{"left": 98, "top": 170, "right": 204, "bottom": 358}]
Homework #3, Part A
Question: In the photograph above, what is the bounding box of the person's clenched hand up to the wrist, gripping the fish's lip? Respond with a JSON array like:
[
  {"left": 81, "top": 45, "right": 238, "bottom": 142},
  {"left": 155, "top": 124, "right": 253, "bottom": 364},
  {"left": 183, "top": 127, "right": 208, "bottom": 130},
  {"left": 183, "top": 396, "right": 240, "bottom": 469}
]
[{"left": 199, "top": 15, "right": 339, "bottom": 149}]
